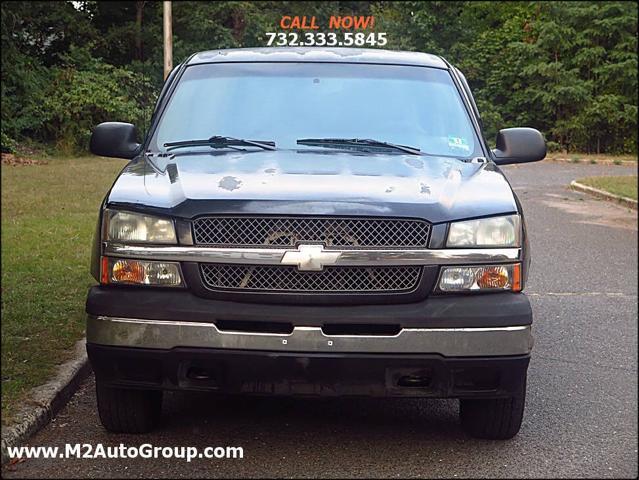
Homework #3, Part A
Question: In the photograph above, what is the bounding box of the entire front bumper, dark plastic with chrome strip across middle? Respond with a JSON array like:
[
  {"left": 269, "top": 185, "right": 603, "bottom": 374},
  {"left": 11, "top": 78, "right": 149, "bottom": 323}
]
[{"left": 87, "top": 287, "right": 533, "bottom": 398}]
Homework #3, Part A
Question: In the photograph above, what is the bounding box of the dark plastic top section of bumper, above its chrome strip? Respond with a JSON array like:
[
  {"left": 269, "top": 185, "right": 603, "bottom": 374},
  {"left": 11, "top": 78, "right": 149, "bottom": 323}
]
[{"left": 86, "top": 286, "right": 532, "bottom": 328}]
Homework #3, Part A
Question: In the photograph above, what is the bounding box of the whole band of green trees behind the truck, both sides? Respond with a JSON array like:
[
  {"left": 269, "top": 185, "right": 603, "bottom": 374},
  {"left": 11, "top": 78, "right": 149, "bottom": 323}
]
[{"left": 2, "top": 1, "right": 637, "bottom": 153}]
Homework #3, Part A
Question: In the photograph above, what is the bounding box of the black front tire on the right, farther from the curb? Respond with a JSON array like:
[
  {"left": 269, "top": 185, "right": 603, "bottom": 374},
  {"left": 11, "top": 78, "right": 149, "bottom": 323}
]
[{"left": 459, "top": 377, "right": 526, "bottom": 440}]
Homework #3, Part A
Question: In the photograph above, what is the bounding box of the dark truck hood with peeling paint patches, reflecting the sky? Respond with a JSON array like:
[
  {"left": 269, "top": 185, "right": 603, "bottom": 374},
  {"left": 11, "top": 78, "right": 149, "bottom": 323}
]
[{"left": 107, "top": 150, "right": 517, "bottom": 223}]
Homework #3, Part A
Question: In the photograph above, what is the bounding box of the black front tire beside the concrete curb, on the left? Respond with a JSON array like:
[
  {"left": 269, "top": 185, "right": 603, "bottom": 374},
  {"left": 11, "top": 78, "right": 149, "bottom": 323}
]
[{"left": 95, "top": 380, "right": 162, "bottom": 433}]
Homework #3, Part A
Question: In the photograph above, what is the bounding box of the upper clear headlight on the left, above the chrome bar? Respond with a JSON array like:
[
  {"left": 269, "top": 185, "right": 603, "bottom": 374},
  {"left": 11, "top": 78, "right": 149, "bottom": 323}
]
[{"left": 105, "top": 210, "right": 177, "bottom": 243}]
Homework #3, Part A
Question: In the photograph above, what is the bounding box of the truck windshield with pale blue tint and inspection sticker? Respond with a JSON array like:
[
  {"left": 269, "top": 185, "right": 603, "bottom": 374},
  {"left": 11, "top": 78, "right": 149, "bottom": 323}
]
[{"left": 150, "top": 63, "right": 482, "bottom": 158}]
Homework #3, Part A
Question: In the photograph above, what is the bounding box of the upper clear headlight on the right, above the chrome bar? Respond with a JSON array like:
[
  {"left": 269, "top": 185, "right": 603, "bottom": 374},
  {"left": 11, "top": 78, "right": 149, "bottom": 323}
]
[{"left": 446, "top": 215, "right": 521, "bottom": 247}]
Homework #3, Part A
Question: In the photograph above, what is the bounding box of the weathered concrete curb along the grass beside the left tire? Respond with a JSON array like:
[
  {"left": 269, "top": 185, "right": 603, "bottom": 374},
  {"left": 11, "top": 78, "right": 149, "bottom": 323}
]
[{"left": 2, "top": 338, "right": 91, "bottom": 465}]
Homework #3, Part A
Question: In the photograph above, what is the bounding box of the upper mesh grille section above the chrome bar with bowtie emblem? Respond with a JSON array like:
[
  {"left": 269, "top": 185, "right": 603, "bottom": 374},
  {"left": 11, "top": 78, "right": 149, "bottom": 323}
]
[{"left": 193, "top": 216, "right": 430, "bottom": 248}]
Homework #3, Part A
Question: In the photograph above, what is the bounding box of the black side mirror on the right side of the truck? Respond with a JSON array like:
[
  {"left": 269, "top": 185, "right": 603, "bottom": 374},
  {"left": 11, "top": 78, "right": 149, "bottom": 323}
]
[{"left": 493, "top": 127, "right": 546, "bottom": 165}]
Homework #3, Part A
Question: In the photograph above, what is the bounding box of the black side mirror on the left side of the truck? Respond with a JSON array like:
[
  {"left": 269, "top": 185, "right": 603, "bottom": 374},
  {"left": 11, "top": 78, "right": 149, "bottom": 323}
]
[{"left": 89, "top": 122, "right": 141, "bottom": 159}]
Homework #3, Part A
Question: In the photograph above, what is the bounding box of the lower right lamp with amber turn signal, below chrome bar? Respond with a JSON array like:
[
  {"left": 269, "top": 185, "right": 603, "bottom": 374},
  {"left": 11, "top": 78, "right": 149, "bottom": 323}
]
[{"left": 438, "top": 263, "right": 521, "bottom": 292}]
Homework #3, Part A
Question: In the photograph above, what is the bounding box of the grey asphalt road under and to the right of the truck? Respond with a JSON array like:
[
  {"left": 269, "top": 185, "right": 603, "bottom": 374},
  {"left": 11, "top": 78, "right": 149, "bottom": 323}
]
[{"left": 2, "top": 162, "right": 637, "bottom": 478}]
